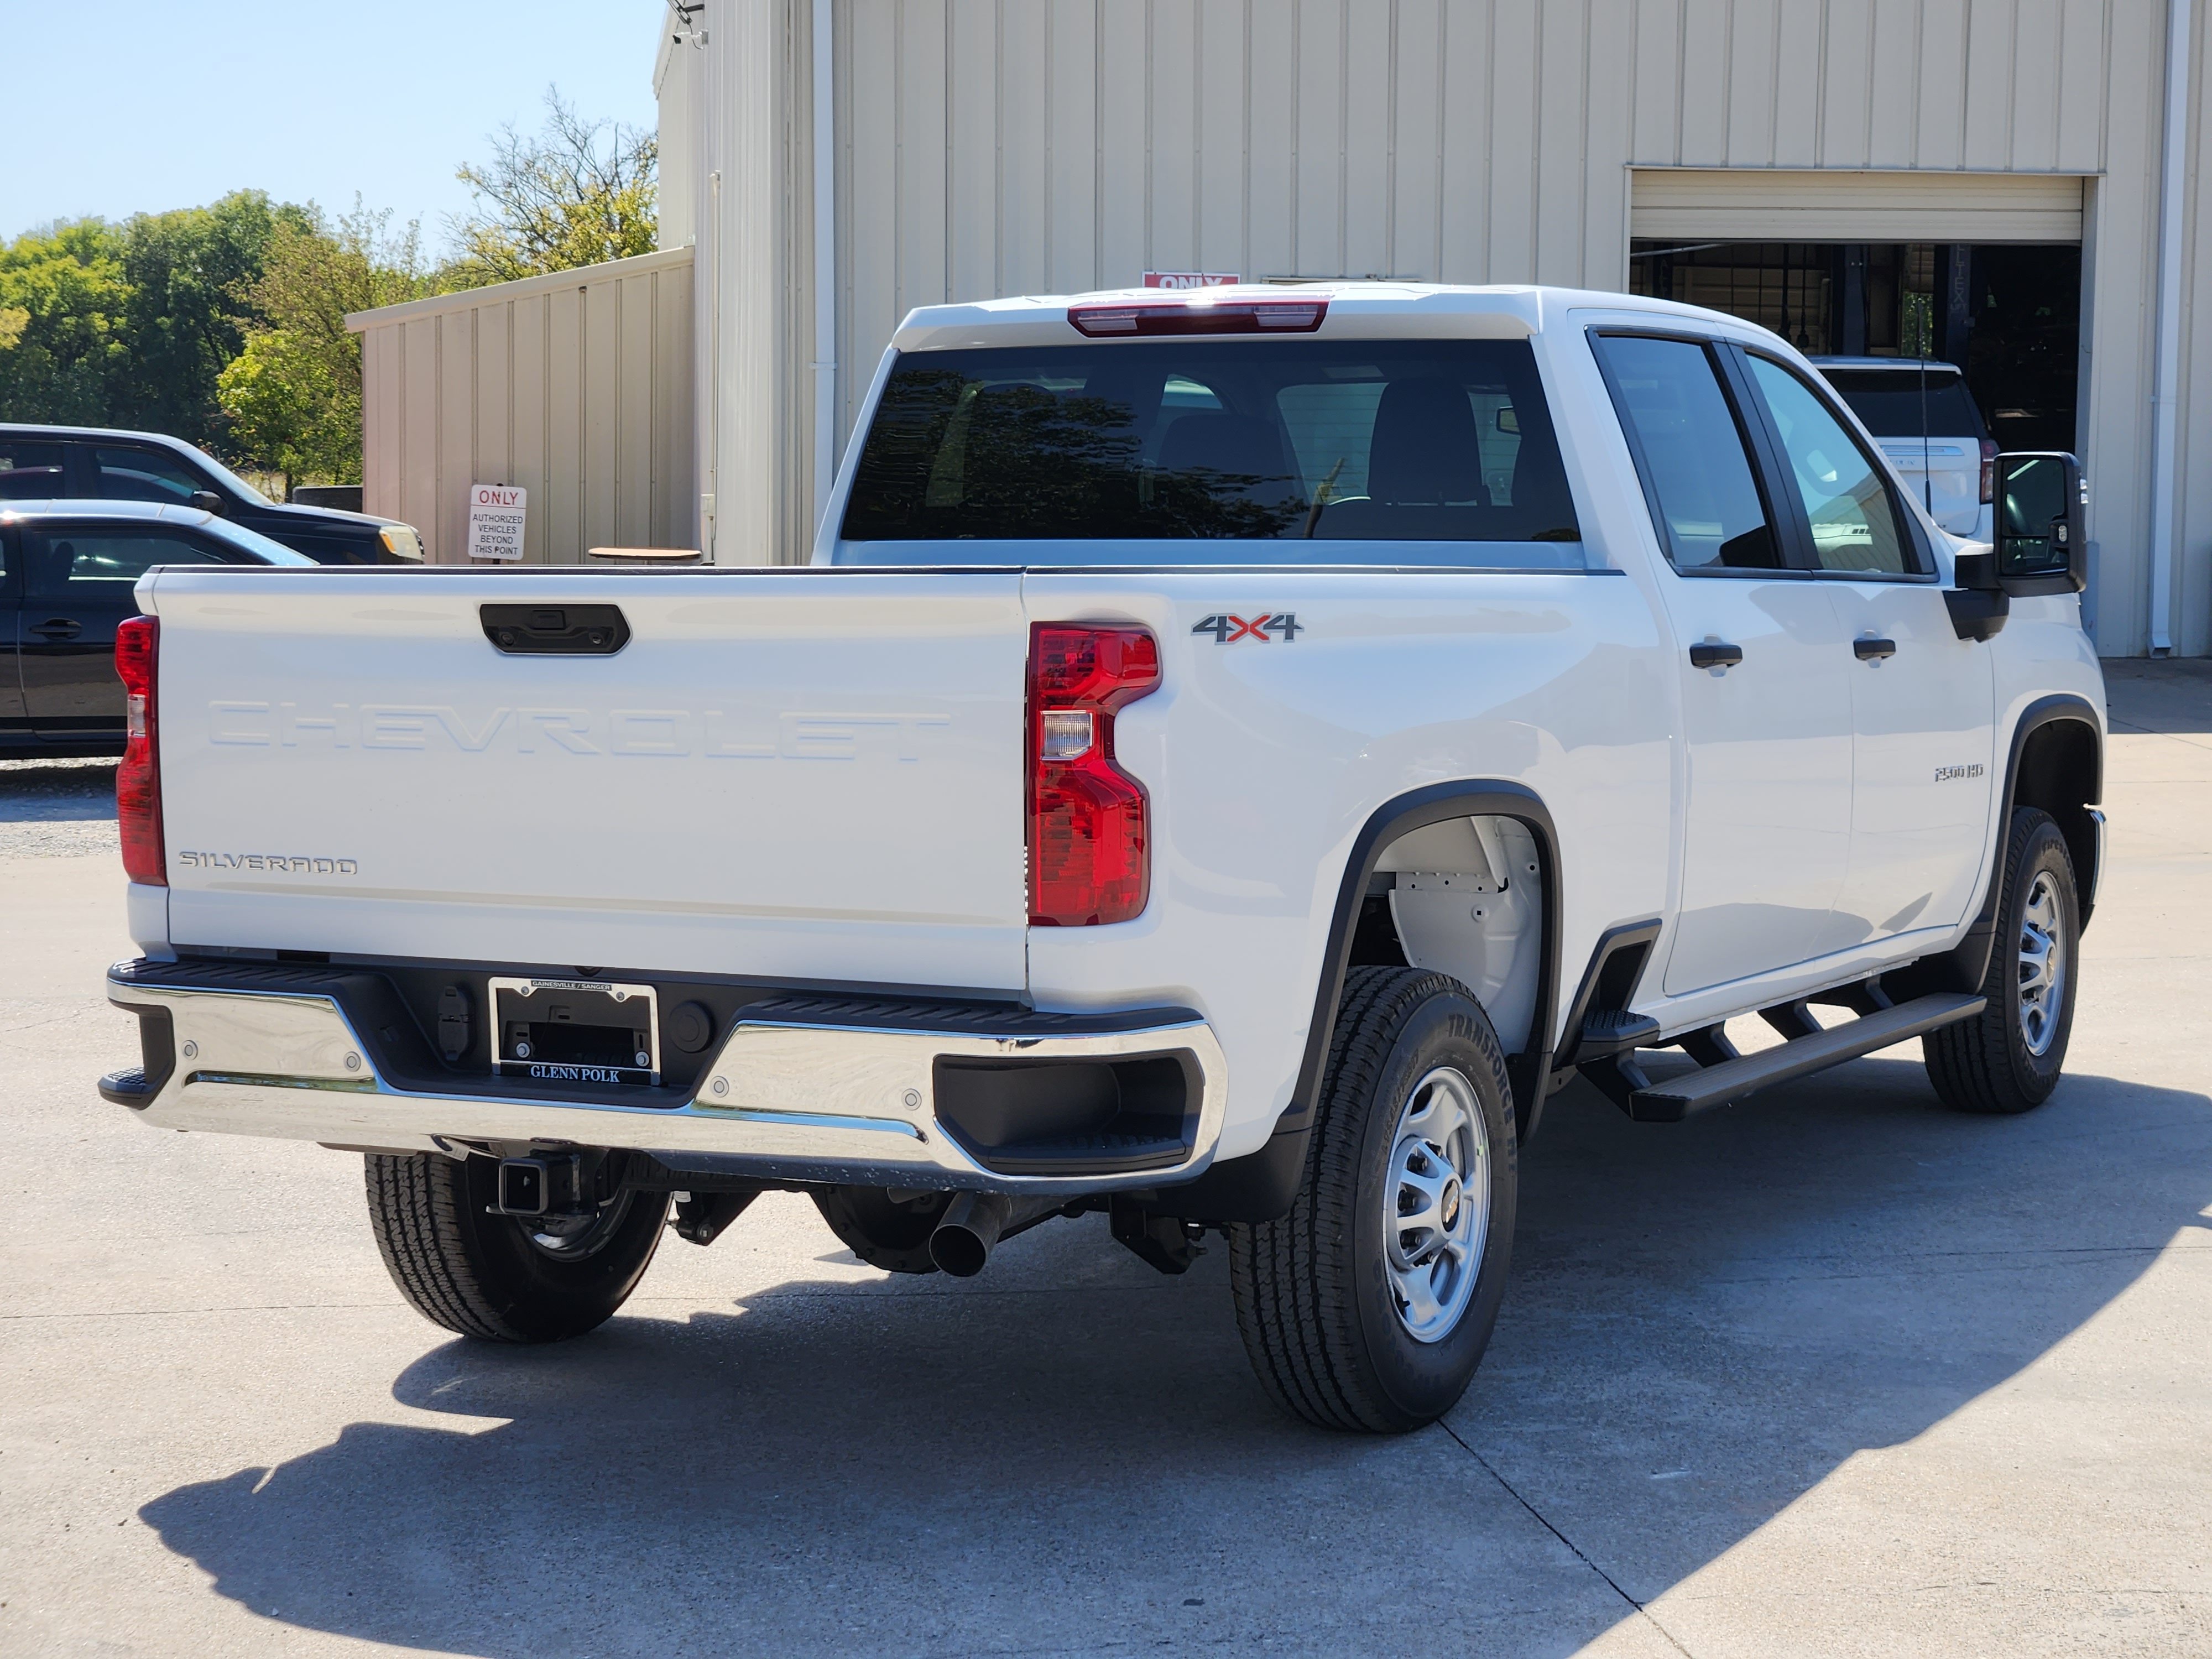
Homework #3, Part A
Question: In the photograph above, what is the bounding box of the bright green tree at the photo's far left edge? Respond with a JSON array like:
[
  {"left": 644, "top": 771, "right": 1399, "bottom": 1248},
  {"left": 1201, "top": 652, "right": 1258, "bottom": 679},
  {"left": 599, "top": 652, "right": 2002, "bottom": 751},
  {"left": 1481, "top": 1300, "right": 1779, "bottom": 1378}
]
[{"left": 0, "top": 219, "right": 131, "bottom": 425}]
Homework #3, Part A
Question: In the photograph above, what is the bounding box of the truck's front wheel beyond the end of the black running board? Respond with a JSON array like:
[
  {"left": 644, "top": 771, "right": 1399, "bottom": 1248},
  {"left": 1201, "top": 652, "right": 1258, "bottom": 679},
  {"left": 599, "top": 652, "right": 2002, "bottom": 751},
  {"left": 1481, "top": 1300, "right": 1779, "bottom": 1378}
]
[{"left": 1920, "top": 807, "right": 2081, "bottom": 1115}]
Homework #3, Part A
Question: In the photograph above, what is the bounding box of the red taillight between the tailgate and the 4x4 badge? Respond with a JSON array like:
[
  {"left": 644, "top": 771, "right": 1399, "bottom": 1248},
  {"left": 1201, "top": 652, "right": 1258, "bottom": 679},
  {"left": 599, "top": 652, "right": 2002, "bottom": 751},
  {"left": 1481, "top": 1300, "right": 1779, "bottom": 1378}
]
[{"left": 1029, "top": 622, "right": 1159, "bottom": 927}]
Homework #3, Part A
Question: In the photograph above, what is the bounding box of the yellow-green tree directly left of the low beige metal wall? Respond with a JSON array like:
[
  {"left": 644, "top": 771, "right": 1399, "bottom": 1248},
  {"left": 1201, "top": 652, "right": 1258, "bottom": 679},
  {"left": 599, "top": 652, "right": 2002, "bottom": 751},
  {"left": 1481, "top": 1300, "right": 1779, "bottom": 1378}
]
[{"left": 217, "top": 199, "right": 431, "bottom": 484}]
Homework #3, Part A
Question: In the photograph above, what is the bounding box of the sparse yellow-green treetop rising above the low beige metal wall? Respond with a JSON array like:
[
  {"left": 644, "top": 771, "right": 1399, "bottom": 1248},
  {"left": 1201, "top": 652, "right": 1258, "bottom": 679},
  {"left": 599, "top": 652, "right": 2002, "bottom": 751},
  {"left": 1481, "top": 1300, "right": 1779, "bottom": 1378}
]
[{"left": 440, "top": 86, "right": 659, "bottom": 288}]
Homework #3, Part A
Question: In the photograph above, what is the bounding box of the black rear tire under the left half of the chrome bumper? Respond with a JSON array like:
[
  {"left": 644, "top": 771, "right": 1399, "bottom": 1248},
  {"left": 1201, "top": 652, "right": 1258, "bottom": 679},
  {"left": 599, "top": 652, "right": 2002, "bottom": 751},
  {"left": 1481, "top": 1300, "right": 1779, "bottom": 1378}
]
[{"left": 365, "top": 1152, "right": 668, "bottom": 1343}]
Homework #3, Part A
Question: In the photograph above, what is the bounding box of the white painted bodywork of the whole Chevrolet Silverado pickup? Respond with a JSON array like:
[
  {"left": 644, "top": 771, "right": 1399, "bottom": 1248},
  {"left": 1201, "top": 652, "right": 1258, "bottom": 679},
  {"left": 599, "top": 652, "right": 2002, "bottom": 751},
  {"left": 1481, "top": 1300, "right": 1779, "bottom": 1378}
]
[{"left": 117, "top": 285, "right": 2101, "bottom": 1194}]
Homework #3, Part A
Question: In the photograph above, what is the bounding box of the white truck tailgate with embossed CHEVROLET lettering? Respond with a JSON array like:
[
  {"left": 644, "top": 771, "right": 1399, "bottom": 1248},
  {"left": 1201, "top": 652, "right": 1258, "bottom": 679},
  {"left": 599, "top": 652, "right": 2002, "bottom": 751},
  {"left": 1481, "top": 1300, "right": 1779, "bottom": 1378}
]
[{"left": 152, "top": 568, "right": 1026, "bottom": 991}]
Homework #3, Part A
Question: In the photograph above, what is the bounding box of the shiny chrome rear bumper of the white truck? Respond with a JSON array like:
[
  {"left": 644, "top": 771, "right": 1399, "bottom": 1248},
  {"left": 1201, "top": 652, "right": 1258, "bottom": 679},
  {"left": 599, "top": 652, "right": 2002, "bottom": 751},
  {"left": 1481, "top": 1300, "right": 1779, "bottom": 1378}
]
[{"left": 102, "top": 962, "right": 1228, "bottom": 1194}]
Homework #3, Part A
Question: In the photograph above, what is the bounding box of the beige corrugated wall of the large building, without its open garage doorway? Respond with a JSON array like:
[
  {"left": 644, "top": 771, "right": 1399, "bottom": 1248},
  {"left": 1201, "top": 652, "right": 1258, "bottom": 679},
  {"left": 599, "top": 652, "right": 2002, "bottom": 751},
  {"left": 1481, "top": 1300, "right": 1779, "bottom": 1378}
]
[{"left": 664, "top": 0, "right": 2212, "bottom": 655}]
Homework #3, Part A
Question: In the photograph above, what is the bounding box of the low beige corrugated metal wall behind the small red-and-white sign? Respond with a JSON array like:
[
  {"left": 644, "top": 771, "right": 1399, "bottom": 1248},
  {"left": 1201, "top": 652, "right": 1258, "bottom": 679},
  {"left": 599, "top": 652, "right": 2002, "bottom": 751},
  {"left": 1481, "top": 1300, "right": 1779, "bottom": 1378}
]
[{"left": 345, "top": 248, "right": 697, "bottom": 564}]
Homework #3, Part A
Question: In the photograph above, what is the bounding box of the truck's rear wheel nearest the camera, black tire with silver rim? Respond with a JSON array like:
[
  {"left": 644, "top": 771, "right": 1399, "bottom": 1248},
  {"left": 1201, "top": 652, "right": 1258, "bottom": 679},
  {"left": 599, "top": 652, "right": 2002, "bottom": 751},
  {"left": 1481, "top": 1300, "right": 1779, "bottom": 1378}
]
[{"left": 1228, "top": 967, "right": 1517, "bottom": 1433}]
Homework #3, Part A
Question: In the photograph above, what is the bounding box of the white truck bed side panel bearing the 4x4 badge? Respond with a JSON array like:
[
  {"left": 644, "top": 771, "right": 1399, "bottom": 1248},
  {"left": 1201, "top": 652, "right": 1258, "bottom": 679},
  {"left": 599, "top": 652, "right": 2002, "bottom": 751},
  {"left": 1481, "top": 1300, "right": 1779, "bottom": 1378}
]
[{"left": 1024, "top": 568, "right": 1672, "bottom": 1157}]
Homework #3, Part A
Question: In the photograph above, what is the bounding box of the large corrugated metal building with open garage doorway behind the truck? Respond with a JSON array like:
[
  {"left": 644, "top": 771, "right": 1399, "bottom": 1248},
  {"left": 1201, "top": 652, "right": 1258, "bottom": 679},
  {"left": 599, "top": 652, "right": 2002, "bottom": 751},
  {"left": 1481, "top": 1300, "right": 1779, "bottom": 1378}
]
[{"left": 354, "top": 0, "right": 2212, "bottom": 655}]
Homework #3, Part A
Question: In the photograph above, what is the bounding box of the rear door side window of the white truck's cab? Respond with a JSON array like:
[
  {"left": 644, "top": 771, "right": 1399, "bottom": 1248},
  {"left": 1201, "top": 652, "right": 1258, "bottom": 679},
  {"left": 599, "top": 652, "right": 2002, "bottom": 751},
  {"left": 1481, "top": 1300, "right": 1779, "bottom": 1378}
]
[{"left": 1599, "top": 334, "right": 1783, "bottom": 571}]
